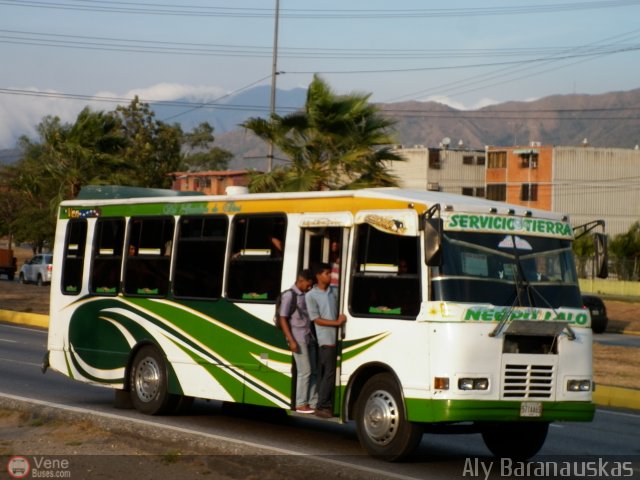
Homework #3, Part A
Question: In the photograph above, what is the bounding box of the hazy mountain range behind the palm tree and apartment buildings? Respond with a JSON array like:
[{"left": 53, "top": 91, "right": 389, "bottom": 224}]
[{"left": 0, "top": 86, "right": 640, "bottom": 170}]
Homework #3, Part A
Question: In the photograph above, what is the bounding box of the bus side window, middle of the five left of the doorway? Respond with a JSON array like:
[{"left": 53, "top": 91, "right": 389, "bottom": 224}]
[{"left": 124, "top": 217, "right": 173, "bottom": 297}]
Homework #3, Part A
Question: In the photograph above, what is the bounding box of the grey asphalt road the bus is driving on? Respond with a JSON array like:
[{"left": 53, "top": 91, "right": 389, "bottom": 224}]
[{"left": 0, "top": 324, "right": 640, "bottom": 479}]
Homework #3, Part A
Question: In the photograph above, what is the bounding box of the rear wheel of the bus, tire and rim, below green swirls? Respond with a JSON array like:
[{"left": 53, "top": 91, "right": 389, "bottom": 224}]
[{"left": 129, "top": 345, "right": 178, "bottom": 415}]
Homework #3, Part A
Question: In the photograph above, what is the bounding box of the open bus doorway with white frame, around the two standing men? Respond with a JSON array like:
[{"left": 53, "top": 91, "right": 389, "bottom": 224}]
[{"left": 293, "top": 213, "right": 353, "bottom": 407}]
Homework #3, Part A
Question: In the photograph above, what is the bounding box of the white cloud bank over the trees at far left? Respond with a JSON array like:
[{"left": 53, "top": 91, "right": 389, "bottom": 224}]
[{"left": 0, "top": 83, "right": 226, "bottom": 149}]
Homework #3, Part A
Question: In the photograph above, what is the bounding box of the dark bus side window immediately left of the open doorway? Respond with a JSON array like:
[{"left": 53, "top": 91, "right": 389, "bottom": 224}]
[{"left": 227, "top": 214, "right": 286, "bottom": 301}]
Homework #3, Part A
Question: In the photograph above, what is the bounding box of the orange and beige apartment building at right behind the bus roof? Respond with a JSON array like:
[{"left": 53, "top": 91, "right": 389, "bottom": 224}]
[{"left": 486, "top": 142, "right": 640, "bottom": 236}]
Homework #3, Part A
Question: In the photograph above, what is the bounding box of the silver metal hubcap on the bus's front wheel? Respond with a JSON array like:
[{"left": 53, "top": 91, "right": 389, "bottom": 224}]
[{"left": 364, "top": 390, "right": 399, "bottom": 445}]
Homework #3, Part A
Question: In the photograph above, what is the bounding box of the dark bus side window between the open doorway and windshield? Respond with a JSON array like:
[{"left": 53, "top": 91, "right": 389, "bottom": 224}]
[{"left": 350, "top": 224, "right": 420, "bottom": 318}]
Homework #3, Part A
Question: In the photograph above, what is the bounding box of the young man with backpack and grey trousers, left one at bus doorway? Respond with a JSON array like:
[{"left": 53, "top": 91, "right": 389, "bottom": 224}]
[{"left": 278, "top": 269, "right": 318, "bottom": 413}]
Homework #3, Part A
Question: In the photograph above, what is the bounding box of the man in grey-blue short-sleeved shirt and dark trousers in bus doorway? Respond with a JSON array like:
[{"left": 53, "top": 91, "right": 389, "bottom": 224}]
[{"left": 305, "top": 263, "right": 347, "bottom": 418}]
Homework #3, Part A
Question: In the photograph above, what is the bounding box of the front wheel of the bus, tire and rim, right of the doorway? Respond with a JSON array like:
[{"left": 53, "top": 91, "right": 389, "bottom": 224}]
[{"left": 355, "top": 373, "right": 423, "bottom": 462}]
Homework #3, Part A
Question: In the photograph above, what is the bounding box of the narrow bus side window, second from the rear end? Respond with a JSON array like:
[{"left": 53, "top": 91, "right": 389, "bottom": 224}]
[{"left": 89, "top": 218, "right": 125, "bottom": 295}]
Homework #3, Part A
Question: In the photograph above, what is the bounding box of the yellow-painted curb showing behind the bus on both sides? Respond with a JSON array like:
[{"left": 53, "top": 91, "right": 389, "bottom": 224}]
[{"left": 0, "top": 310, "right": 640, "bottom": 410}]
